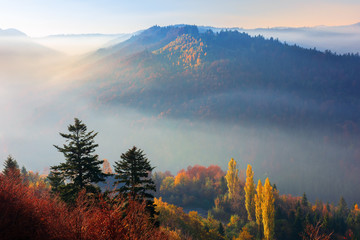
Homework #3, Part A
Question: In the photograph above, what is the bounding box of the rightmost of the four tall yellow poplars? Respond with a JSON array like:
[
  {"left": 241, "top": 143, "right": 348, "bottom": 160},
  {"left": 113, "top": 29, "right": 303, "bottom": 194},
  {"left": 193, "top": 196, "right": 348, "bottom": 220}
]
[{"left": 261, "top": 178, "right": 275, "bottom": 240}]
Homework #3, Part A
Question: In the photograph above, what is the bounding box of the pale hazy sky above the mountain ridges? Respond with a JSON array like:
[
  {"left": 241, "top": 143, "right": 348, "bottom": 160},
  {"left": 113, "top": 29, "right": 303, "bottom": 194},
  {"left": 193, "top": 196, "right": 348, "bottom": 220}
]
[{"left": 0, "top": 0, "right": 360, "bottom": 37}]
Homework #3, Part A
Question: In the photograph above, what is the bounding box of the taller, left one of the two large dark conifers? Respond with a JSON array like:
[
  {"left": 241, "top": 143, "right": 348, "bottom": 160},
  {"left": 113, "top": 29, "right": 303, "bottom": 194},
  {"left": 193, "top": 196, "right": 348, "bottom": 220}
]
[{"left": 51, "top": 118, "right": 105, "bottom": 202}]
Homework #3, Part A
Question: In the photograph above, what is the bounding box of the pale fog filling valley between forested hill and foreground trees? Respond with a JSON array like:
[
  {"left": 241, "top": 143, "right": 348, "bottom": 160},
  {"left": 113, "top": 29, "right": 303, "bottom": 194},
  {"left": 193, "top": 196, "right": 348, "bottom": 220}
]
[{"left": 0, "top": 29, "right": 360, "bottom": 203}]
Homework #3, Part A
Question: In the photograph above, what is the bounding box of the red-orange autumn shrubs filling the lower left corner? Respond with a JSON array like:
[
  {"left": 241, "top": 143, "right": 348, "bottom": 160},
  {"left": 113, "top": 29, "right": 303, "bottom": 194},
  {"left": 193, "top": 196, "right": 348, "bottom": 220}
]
[{"left": 0, "top": 174, "right": 168, "bottom": 240}]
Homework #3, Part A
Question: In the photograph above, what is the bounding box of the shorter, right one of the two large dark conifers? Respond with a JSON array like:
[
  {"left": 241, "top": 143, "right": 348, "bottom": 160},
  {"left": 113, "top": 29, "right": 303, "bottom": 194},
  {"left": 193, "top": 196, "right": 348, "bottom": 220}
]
[{"left": 114, "top": 146, "right": 157, "bottom": 220}]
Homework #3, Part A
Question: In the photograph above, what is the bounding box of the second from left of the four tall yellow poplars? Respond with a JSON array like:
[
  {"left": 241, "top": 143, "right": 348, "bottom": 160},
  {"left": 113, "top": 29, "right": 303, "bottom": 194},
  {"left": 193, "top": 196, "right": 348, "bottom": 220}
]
[{"left": 244, "top": 164, "right": 255, "bottom": 221}]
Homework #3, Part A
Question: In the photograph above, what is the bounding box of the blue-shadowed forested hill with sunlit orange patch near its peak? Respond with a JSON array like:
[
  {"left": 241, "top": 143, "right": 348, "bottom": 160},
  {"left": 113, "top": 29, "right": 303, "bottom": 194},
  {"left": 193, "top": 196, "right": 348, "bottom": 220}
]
[{"left": 86, "top": 26, "right": 360, "bottom": 134}]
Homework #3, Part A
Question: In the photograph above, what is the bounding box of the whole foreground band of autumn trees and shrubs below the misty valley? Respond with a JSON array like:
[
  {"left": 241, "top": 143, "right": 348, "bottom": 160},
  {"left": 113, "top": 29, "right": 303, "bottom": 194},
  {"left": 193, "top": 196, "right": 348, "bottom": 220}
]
[{"left": 0, "top": 118, "right": 360, "bottom": 240}]
